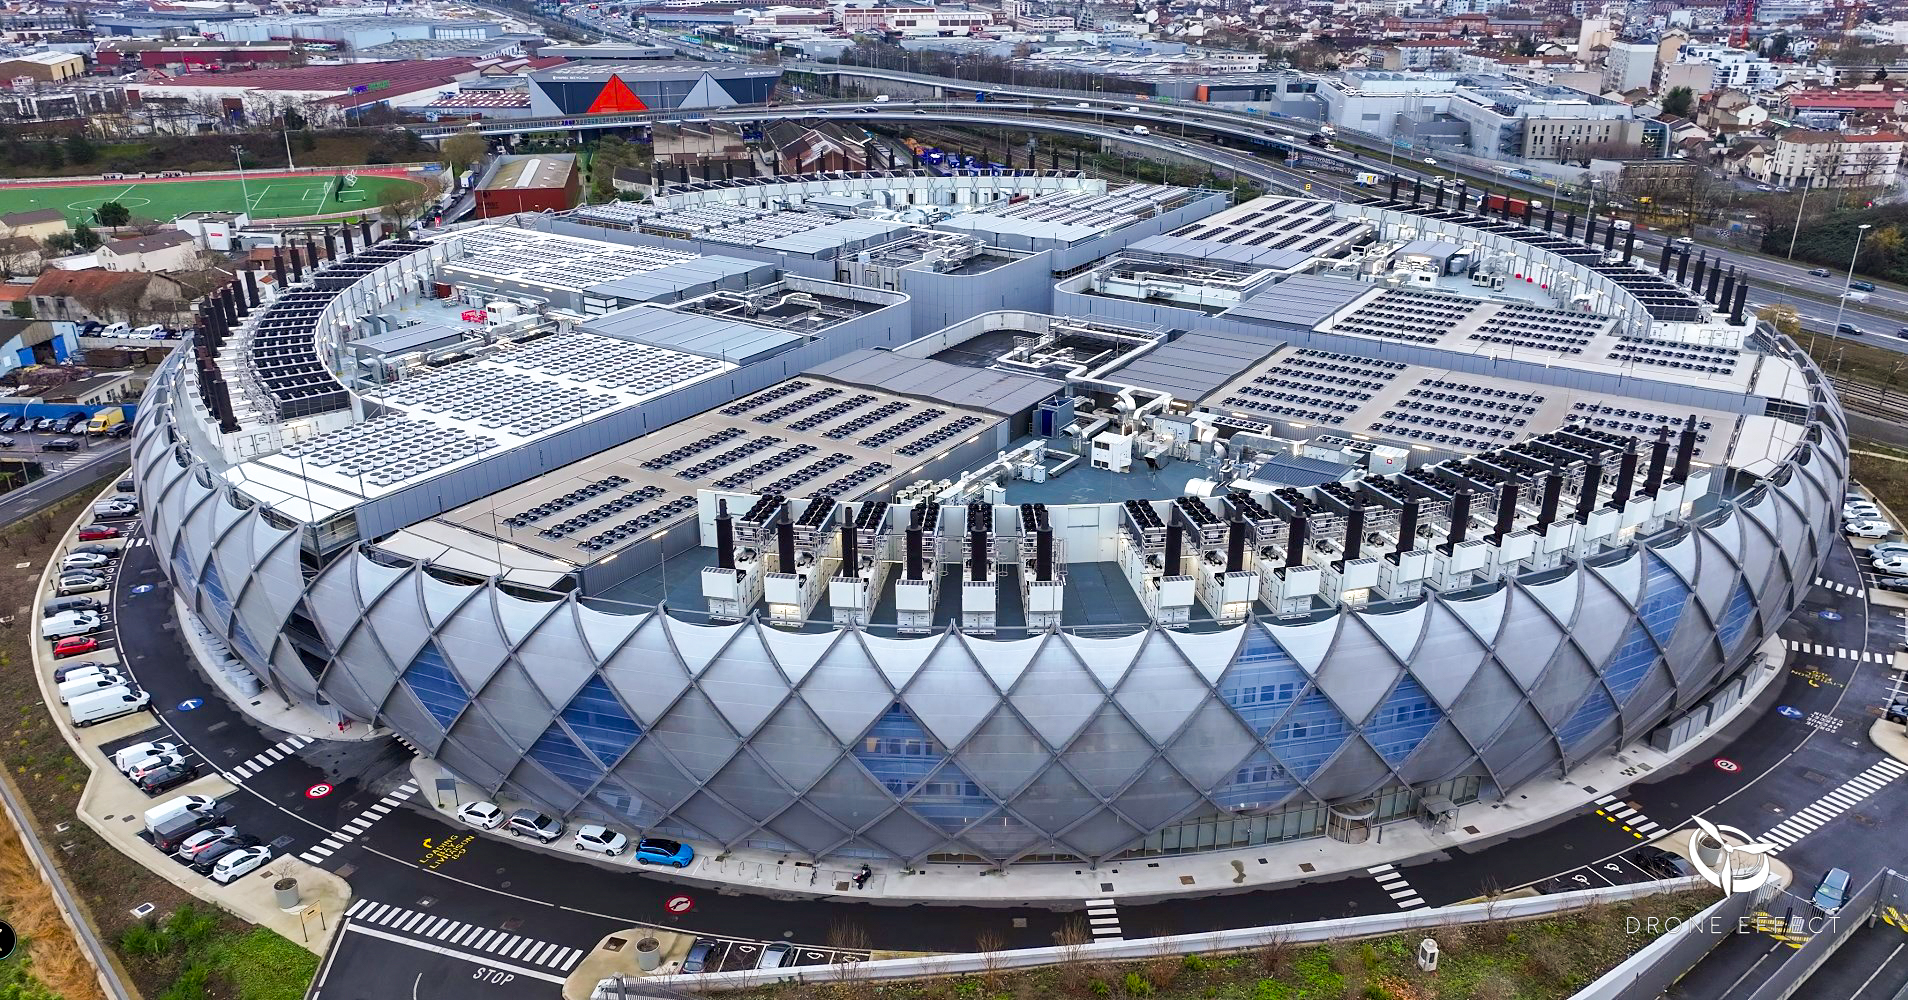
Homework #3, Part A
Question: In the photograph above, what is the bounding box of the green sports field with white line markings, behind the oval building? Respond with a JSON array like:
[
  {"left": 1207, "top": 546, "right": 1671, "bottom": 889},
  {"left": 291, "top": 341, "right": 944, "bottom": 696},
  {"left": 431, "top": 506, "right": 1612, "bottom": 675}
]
[{"left": 0, "top": 174, "right": 420, "bottom": 223}]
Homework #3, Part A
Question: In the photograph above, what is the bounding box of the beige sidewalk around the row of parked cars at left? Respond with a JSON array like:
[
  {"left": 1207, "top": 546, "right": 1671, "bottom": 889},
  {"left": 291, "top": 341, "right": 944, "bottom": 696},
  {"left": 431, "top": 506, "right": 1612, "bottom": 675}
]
[{"left": 31, "top": 500, "right": 351, "bottom": 954}]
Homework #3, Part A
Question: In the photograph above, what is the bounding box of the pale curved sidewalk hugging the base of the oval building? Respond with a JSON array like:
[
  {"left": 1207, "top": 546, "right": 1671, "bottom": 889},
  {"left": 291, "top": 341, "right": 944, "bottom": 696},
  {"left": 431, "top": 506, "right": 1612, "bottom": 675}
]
[{"left": 410, "top": 637, "right": 1788, "bottom": 908}]
